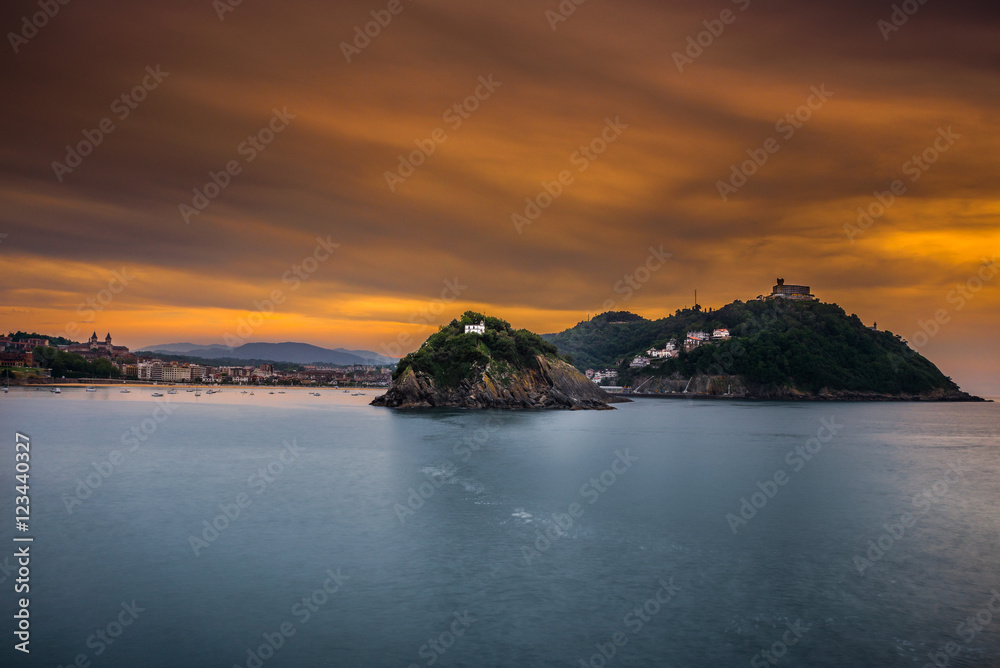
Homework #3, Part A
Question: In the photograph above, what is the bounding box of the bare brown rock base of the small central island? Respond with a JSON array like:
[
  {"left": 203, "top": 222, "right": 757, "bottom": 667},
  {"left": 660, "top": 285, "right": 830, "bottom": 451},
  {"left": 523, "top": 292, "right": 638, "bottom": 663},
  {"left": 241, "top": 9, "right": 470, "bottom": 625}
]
[{"left": 372, "top": 355, "right": 627, "bottom": 410}]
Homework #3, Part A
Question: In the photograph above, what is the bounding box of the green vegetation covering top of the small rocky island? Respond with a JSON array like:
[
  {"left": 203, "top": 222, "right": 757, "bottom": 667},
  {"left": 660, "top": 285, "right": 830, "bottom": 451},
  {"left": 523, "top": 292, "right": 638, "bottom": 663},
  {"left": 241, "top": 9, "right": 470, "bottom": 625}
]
[{"left": 392, "top": 311, "right": 558, "bottom": 388}]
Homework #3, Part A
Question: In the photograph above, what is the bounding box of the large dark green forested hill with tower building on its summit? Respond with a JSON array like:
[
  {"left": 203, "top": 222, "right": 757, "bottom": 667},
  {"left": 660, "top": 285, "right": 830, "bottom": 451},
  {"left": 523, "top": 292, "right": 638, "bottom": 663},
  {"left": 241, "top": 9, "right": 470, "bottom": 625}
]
[{"left": 544, "top": 300, "right": 972, "bottom": 395}]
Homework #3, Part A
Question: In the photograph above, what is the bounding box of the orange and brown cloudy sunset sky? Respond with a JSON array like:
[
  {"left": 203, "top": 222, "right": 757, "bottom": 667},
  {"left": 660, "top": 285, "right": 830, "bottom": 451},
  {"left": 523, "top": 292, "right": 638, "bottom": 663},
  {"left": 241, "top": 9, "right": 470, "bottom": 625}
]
[{"left": 0, "top": 0, "right": 1000, "bottom": 395}]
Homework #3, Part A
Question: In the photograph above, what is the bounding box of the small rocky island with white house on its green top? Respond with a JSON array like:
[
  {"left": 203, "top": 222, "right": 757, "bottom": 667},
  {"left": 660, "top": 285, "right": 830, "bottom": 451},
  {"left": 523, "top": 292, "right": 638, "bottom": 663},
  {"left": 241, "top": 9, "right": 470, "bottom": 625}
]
[{"left": 372, "top": 311, "right": 621, "bottom": 410}]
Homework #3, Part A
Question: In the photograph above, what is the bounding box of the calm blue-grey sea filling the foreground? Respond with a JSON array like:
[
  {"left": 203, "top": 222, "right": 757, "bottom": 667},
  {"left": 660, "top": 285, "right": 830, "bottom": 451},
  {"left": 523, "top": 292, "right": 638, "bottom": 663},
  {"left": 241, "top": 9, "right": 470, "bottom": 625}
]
[{"left": 0, "top": 388, "right": 1000, "bottom": 668}]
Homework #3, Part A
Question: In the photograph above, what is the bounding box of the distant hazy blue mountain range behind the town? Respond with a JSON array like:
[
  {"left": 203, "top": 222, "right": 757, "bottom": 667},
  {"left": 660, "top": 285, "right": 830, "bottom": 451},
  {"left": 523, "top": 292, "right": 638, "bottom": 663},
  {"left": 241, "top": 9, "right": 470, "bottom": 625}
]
[{"left": 137, "top": 341, "right": 398, "bottom": 366}]
